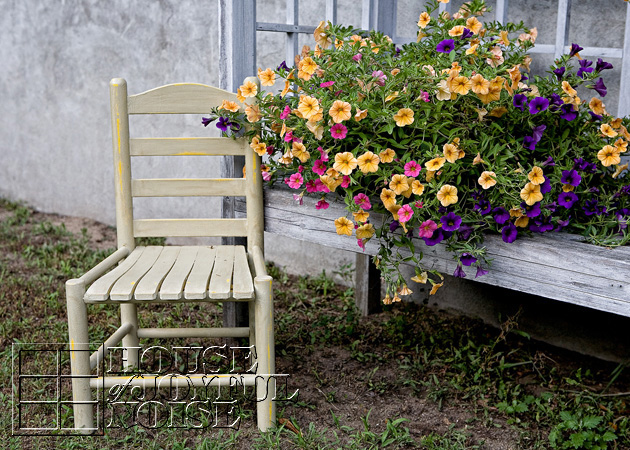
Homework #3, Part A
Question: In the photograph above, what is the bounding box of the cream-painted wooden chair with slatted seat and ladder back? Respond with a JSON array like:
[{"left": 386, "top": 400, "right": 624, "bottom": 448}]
[{"left": 66, "top": 77, "right": 275, "bottom": 433}]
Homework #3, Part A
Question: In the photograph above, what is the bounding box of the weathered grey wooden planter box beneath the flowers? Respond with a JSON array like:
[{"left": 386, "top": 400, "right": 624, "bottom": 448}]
[{"left": 236, "top": 188, "right": 630, "bottom": 317}]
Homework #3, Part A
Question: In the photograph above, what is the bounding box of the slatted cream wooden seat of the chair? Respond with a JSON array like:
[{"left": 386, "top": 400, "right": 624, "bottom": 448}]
[{"left": 84, "top": 245, "right": 254, "bottom": 303}]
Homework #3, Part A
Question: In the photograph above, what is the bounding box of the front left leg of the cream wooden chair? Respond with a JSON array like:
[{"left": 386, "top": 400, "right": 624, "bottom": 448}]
[{"left": 66, "top": 280, "right": 94, "bottom": 434}]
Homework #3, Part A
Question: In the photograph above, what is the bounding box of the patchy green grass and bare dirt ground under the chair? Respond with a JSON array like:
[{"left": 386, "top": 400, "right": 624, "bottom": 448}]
[{"left": 0, "top": 200, "right": 630, "bottom": 449}]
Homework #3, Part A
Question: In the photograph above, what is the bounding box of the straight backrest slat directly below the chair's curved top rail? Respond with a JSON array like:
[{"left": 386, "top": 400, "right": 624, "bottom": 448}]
[{"left": 129, "top": 137, "right": 247, "bottom": 156}]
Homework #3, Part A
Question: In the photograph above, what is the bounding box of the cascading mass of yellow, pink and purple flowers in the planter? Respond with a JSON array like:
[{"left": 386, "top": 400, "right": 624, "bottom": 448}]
[{"left": 203, "top": 0, "right": 630, "bottom": 303}]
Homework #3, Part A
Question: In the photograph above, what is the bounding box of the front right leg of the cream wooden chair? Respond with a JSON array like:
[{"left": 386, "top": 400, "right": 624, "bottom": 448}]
[{"left": 254, "top": 276, "right": 276, "bottom": 431}]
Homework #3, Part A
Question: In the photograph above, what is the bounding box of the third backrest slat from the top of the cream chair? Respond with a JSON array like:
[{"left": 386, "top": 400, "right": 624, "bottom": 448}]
[{"left": 131, "top": 178, "right": 246, "bottom": 197}]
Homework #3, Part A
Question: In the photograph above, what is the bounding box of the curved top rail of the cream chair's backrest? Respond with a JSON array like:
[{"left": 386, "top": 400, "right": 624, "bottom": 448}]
[{"left": 127, "top": 83, "right": 237, "bottom": 114}]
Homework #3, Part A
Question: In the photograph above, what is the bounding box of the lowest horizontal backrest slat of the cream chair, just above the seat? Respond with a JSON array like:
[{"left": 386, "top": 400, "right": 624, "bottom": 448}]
[{"left": 133, "top": 219, "right": 247, "bottom": 237}]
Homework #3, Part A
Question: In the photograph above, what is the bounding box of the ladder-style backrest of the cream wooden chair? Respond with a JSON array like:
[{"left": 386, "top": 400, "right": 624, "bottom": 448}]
[{"left": 110, "top": 77, "right": 264, "bottom": 251}]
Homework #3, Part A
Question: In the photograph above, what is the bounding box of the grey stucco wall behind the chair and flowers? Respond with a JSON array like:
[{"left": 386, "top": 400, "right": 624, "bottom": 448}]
[{"left": 0, "top": 0, "right": 626, "bottom": 272}]
